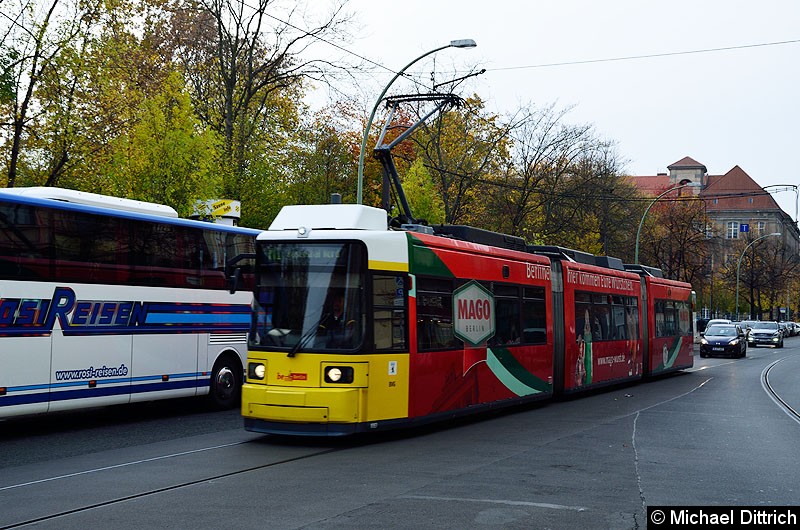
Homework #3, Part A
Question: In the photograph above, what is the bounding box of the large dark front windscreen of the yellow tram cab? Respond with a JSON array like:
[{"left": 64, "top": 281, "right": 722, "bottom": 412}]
[{"left": 250, "top": 241, "right": 367, "bottom": 353}]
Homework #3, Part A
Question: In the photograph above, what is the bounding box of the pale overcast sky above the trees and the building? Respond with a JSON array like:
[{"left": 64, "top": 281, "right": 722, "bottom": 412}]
[{"left": 304, "top": 0, "right": 800, "bottom": 217}]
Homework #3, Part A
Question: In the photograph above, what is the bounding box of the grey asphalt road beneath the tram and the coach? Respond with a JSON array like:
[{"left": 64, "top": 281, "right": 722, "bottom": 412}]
[{"left": 0, "top": 337, "right": 800, "bottom": 529}]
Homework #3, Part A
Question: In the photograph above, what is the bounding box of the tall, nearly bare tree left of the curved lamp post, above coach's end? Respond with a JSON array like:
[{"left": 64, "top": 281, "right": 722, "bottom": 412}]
[{"left": 158, "top": 0, "right": 349, "bottom": 199}]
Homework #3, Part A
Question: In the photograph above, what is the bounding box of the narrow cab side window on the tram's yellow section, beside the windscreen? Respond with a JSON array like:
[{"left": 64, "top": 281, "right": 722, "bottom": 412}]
[{"left": 372, "top": 273, "right": 408, "bottom": 351}]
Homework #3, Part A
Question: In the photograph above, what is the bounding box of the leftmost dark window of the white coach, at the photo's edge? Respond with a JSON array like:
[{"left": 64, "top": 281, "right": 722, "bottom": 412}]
[{"left": 0, "top": 200, "right": 52, "bottom": 280}]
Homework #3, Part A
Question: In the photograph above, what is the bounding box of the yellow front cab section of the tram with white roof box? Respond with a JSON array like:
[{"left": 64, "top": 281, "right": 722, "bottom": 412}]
[{"left": 242, "top": 205, "right": 410, "bottom": 436}]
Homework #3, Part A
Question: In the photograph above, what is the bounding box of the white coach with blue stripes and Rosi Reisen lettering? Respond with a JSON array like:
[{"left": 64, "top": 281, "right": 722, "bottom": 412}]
[{"left": 0, "top": 188, "right": 259, "bottom": 418}]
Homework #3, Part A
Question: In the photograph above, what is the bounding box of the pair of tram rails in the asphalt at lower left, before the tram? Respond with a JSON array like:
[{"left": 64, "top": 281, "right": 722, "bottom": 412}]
[{"left": 0, "top": 439, "right": 346, "bottom": 530}]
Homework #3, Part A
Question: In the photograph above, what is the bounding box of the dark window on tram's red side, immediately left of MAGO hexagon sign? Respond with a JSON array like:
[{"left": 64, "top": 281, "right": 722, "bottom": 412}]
[{"left": 417, "top": 278, "right": 461, "bottom": 351}]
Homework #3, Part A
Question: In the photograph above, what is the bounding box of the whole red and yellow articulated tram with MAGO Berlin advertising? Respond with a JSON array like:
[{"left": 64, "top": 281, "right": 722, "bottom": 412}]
[{"left": 242, "top": 204, "right": 691, "bottom": 436}]
